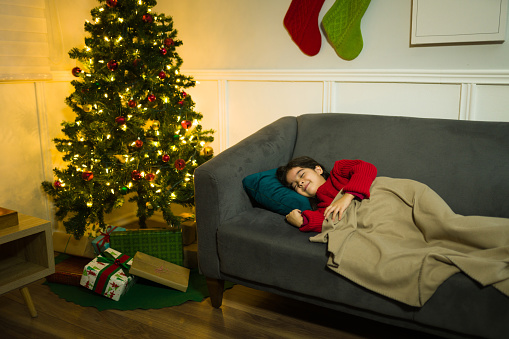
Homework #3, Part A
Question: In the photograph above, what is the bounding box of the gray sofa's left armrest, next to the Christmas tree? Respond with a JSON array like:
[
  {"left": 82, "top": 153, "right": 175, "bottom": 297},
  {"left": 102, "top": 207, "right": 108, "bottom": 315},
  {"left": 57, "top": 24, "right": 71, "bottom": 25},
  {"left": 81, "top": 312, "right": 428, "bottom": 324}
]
[{"left": 194, "top": 117, "right": 297, "bottom": 279}]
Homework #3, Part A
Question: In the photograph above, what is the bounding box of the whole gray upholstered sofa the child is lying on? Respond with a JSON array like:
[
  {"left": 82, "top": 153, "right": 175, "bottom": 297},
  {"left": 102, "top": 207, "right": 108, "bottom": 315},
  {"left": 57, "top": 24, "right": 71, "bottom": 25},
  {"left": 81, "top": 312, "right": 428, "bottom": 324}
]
[{"left": 195, "top": 113, "right": 509, "bottom": 338}]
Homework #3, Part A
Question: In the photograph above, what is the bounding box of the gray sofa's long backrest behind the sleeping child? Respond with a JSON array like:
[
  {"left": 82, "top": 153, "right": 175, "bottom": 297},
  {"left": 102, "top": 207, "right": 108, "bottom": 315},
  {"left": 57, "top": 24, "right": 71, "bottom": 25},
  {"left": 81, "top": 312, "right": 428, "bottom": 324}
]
[{"left": 293, "top": 113, "right": 509, "bottom": 217}]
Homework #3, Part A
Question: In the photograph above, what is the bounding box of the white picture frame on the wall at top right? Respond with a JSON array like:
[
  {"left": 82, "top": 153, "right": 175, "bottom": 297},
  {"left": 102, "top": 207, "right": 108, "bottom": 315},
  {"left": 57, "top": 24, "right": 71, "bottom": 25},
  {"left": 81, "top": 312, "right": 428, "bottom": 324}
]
[{"left": 410, "top": 0, "right": 508, "bottom": 46}]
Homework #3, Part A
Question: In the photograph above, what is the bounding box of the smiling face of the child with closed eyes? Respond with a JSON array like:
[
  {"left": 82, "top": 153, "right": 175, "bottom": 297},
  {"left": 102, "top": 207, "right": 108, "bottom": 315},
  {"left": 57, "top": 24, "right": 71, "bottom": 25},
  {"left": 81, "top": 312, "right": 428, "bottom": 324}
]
[{"left": 286, "top": 166, "right": 325, "bottom": 198}]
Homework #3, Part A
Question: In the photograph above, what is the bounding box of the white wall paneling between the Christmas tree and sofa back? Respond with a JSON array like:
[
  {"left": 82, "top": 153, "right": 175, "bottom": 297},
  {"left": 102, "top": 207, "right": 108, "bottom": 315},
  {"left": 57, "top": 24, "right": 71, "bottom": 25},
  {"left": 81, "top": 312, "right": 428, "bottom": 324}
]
[{"left": 185, "top": 70, "right": 509, "bottom": 151}]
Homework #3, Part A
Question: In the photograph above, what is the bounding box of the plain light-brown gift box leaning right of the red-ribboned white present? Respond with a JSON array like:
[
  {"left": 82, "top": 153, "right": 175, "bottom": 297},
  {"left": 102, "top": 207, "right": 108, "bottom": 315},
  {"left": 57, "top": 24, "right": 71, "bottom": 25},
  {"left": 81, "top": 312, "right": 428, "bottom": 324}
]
[{"left": 129, "top": 252, "right": 190, "bottom": 292}]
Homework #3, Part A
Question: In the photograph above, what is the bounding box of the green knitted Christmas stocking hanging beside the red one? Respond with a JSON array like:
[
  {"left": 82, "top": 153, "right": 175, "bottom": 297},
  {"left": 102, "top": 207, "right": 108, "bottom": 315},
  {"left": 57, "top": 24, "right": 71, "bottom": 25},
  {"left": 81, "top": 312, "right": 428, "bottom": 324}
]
[{"left": 322, "top": 0, "right": 371, "bottom": 60}]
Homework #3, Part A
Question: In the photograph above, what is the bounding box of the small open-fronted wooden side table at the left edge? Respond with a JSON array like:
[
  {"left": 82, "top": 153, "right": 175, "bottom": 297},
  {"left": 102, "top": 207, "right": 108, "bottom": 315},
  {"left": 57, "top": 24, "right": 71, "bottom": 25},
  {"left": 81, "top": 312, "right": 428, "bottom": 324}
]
[{"left": 0, "top": 214, "right": 55, "bottom": 317}]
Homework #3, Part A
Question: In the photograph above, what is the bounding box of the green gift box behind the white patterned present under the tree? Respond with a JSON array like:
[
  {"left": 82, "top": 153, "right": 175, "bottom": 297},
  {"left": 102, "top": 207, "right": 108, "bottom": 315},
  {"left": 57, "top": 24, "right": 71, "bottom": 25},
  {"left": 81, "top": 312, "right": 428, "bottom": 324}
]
[{"left": 110, "top": 229, "right": 184, "bottom": 266}]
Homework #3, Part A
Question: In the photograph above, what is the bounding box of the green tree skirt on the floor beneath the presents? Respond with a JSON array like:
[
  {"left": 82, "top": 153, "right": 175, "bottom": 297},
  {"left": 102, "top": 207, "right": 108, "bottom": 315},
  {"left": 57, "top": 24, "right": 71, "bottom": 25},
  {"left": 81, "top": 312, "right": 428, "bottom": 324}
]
[{"left": 45, "top": 256, "right": 234, "bottom": 311}]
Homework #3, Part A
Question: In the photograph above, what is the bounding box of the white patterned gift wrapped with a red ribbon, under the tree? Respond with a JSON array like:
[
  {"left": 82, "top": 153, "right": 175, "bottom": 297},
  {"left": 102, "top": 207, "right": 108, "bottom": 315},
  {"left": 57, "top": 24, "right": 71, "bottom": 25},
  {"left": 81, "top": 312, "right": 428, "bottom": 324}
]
[{"left": 80, "top": 248, "right": 135, "bottom": 301}]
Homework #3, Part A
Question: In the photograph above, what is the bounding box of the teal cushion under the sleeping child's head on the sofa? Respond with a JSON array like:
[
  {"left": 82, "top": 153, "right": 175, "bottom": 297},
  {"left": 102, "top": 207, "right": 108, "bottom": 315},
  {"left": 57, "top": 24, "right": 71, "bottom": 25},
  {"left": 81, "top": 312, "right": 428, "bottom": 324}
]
[{"left": 242, "top": 168, "right": 311, "bottom": 215}]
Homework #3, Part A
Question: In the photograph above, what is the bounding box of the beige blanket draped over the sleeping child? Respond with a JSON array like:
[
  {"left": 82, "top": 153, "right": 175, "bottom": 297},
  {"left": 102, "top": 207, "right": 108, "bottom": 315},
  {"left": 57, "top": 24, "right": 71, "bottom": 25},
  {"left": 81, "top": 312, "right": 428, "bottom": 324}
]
[{"left": 310, "top": 177, "right": 509, "bottom": 306}]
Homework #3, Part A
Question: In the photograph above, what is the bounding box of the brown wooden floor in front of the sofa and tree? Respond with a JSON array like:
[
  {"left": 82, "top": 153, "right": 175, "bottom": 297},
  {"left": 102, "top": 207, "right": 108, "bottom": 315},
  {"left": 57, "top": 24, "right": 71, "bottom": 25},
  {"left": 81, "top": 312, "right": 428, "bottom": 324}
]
[{"left": 0, "top": 280, "right": 436, "bottom": 339}]
